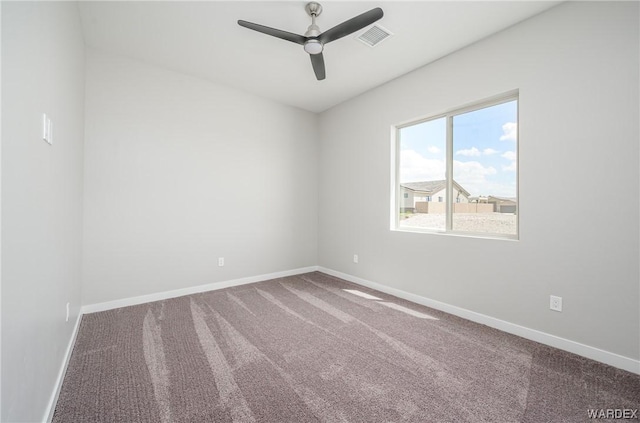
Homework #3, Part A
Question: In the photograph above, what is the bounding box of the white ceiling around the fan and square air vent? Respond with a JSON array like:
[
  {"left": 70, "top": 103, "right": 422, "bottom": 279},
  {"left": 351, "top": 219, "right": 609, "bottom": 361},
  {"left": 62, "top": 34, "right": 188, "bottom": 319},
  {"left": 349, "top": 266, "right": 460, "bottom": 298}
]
[{"left": 80, "top": 1, "right": 559, "bottom": 112}]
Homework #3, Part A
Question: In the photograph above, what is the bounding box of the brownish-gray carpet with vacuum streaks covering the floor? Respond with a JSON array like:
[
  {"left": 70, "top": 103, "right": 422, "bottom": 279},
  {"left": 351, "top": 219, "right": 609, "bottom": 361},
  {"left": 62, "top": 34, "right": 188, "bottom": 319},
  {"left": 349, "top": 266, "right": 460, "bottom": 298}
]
[{"left": 53, "top": 272, "right": 640, "bottom": 423}]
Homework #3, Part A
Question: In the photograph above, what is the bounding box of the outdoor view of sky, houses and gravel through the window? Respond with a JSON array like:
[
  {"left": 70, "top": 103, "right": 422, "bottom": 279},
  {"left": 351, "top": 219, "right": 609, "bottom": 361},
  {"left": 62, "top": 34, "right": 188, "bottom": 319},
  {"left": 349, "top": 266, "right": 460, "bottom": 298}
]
[{"left": 396, "top": 96, "right": 518, "bottom": 238}]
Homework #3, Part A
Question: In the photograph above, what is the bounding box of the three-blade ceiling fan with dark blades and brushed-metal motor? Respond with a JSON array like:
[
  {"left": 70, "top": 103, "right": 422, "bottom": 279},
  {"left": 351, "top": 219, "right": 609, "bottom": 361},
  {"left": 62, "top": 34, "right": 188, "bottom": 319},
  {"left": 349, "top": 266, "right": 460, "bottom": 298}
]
[{"left": 238, "top": 2, "right": 384, "bottom": 81}]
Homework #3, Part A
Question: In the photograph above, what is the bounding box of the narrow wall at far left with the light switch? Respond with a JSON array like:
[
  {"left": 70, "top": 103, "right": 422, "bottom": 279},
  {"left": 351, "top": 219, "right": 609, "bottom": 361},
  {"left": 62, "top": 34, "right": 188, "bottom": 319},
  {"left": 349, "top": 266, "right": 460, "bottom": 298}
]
[{"left": 0, "top": 2, "right": 84, "bottom": 422}]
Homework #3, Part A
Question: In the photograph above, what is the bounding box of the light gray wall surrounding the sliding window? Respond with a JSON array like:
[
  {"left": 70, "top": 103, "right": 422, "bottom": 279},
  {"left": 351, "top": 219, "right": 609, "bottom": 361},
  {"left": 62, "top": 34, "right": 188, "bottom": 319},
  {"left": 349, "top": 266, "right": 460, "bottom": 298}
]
[{"left": 318, "top": 2, "right": 640, "bottom": 360}]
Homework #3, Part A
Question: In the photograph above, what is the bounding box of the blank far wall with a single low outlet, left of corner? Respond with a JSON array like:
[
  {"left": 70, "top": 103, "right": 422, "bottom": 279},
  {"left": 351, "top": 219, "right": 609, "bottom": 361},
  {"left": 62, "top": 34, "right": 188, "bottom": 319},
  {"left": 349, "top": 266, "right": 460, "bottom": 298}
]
[{"left": 83, "top": 51, "right": 318, "bottom": 304}]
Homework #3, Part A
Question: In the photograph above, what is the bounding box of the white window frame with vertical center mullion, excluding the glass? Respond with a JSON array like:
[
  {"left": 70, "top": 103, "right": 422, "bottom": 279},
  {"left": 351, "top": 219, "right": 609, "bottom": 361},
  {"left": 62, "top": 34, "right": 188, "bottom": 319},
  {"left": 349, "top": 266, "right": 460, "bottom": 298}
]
[{"left": 390, "top": 90, "right": 520, "bottom": 240}]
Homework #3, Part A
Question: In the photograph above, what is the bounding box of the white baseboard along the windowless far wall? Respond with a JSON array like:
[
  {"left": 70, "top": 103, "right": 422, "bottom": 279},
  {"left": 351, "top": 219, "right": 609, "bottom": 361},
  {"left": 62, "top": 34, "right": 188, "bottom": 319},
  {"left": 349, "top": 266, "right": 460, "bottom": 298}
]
[{"left": 81, "top": 266, "right": 318, "bottom": 314}]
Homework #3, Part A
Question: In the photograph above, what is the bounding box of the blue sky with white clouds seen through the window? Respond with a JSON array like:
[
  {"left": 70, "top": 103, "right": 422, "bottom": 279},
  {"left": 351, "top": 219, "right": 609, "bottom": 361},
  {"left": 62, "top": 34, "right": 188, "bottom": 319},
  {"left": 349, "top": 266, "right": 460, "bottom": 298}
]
[{"left": 400, "top": 100, "right": 518, "bottom": 197}]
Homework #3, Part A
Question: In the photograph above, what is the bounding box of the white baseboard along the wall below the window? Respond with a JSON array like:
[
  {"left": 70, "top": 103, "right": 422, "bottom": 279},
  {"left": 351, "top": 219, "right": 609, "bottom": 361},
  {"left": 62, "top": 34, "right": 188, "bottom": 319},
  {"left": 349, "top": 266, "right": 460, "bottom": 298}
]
[{"left": 318, "top": 266, "right": 640, "bottom": 374}]
